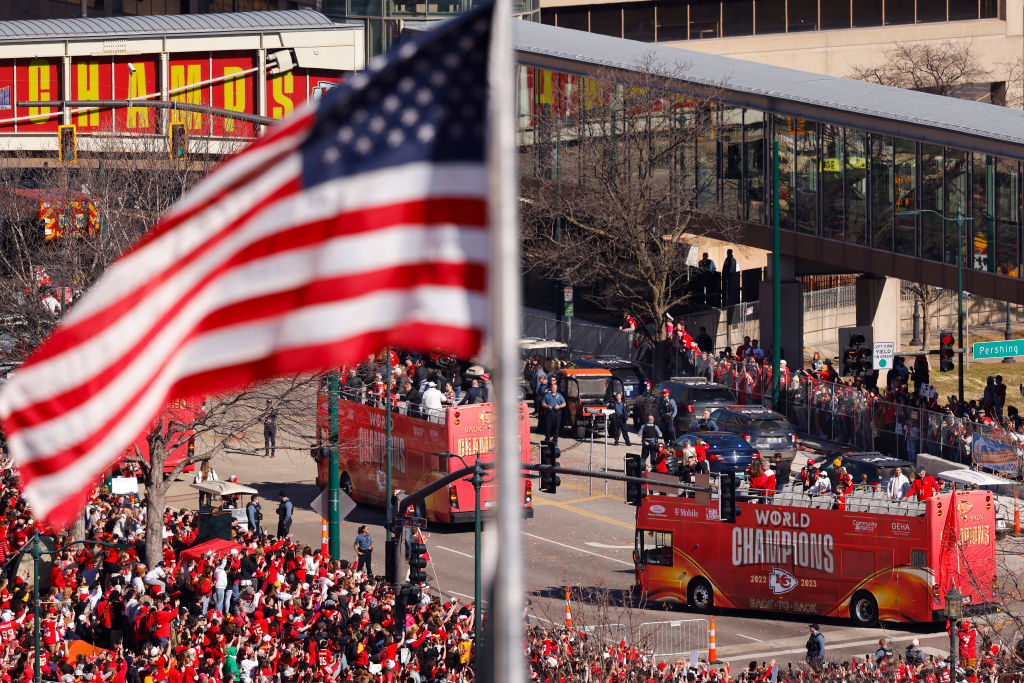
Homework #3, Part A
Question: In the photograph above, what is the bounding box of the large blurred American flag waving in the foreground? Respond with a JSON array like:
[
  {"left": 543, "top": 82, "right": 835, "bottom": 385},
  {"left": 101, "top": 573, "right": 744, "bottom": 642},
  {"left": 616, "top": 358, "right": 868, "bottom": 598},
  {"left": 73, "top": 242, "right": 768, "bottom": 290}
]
[{"left": 0, "top": 3, "right": 493, "bottom": 524}]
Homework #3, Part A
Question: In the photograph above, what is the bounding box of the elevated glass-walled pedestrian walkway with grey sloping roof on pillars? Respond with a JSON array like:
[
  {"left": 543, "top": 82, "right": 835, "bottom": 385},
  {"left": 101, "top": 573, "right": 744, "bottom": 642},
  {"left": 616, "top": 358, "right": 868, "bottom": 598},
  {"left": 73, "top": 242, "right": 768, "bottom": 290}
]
[{"left": 514, "top": 22, "right": 1024, "bottom": 362}]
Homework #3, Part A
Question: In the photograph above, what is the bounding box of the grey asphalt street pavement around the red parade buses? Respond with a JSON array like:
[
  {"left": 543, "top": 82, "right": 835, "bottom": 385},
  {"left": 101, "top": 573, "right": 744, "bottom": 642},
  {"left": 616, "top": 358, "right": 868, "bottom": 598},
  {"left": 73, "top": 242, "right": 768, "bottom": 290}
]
[{"left": 168, "top": 405, "right": 948, "bottom": 666}]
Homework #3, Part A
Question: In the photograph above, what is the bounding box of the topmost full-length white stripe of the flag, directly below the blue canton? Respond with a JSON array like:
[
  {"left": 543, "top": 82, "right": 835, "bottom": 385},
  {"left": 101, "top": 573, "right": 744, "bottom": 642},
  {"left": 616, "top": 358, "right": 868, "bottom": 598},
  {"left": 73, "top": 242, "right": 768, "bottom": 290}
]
[{"left": 0, "top": 164, "right": 485, "bottom": 416}]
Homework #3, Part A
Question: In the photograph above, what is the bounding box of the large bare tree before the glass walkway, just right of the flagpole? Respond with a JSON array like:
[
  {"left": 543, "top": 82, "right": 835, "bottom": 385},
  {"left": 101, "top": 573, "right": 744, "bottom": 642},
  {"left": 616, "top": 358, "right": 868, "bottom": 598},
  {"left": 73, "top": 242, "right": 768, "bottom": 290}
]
[{"left": 520, "top": 59, "right": 732, "bottom": 339}]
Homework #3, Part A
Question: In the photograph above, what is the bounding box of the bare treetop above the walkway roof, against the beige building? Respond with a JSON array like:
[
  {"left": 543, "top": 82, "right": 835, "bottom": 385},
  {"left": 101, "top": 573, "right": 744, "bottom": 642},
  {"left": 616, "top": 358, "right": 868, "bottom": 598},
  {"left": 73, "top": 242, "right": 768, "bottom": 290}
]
[{"left": 848, "top": 40, "right": 989, "bottom": 95}]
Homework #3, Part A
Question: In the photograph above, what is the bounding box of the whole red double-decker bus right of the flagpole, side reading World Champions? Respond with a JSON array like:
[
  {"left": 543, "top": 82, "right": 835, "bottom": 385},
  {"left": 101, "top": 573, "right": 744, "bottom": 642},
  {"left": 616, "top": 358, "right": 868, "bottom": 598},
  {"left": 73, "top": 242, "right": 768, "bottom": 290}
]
[{"left": 634, "top": 485, "right": 996, "bottom": 626}]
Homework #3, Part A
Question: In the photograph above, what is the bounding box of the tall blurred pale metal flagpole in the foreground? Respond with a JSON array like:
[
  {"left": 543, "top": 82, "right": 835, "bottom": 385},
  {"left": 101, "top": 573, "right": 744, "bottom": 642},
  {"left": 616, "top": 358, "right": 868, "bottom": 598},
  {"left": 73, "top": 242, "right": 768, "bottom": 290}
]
[{"left": 479, "top": 0, "right": 527, "bottom": 683}]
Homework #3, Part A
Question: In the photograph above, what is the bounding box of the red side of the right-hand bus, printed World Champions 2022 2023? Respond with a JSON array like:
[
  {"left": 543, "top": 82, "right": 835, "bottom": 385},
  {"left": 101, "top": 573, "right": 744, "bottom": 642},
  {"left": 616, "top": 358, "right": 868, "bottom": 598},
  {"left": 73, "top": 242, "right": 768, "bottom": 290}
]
[{"left": 637, "top": 497, "right": 932, "bottom": 622}]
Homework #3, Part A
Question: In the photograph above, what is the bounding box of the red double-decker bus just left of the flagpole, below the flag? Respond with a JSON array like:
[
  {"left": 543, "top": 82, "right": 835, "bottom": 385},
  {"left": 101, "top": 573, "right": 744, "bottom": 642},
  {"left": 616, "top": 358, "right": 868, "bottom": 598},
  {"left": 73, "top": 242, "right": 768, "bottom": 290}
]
[{"left": 313, "top": 385, "right": 534, "bottom": 524}]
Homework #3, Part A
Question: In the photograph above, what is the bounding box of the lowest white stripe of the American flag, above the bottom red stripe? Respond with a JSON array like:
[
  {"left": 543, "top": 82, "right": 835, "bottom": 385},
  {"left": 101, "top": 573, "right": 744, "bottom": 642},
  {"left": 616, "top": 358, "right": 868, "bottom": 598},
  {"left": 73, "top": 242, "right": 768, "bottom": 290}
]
[{"left": 11, "top": 286, "right": 487, "bottom": 516}]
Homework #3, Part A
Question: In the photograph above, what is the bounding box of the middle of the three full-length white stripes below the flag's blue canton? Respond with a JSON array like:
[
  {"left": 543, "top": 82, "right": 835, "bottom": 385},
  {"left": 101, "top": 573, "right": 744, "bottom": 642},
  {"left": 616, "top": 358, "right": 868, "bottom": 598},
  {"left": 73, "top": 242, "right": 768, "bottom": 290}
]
[{"left": 7, "top": 225, "right": 489, "bottom": 461}]
